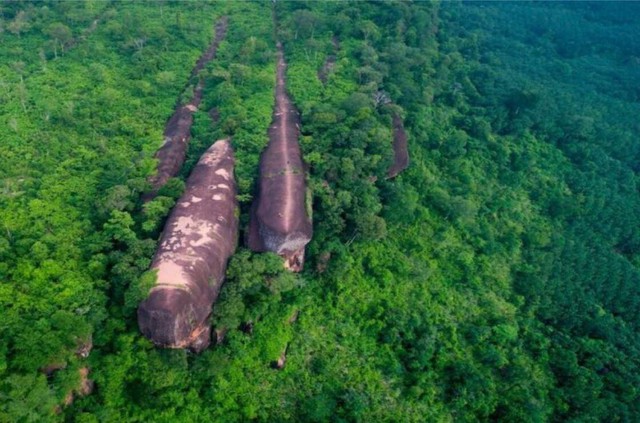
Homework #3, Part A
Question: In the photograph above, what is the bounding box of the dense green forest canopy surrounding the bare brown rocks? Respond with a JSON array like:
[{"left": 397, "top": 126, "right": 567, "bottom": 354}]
[{"left": 0, "top": 1, "right": 640, "bottom": 422}]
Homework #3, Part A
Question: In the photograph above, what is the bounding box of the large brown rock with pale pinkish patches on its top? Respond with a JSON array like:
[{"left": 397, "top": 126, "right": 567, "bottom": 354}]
[{"left": 138, "top": 140, "right": 238, "bottom": 351}]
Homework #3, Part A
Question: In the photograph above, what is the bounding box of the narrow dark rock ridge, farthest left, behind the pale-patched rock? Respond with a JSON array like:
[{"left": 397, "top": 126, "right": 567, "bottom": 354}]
[{"left": 143, "top": 16, "right": 228, "bottom": 202}]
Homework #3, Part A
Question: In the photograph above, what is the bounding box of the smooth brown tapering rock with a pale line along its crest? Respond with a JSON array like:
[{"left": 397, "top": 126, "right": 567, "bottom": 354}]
[{"left": 248, "top": 43, "right": 312, "bottom": 272}]
